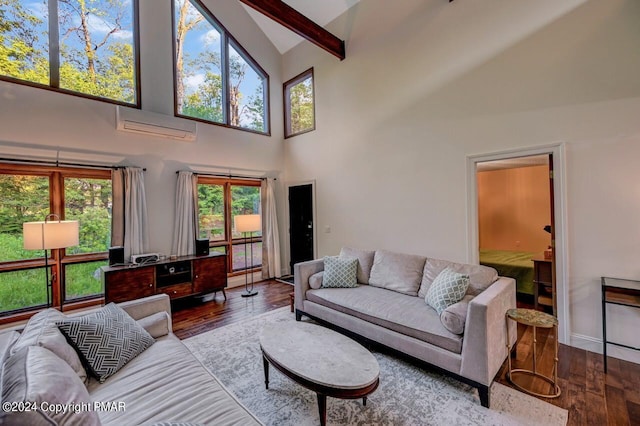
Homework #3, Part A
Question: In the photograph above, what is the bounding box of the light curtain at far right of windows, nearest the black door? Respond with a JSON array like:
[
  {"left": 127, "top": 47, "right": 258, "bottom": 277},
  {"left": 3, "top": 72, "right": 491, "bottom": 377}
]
[{"left": 260, "top": 179, "right": 281, "bottom": 279}]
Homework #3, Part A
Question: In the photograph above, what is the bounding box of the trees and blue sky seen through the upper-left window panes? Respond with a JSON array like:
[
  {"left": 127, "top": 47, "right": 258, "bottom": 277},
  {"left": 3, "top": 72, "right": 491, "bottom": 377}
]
[{"left": 0, "top": 0, "right": 136, "bottom": 103}]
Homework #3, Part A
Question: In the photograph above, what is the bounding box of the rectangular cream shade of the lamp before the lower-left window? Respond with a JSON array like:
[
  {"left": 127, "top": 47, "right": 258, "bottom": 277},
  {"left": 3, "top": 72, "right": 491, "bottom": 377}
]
[{"left": 22, "top": 220, "right": 80, "bottom": 250}]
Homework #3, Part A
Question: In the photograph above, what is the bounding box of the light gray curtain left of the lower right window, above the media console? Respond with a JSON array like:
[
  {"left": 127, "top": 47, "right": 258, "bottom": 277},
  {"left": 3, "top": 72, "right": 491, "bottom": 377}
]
[{"left": 171, "top": 171, "right": 198, "bottom": 256}]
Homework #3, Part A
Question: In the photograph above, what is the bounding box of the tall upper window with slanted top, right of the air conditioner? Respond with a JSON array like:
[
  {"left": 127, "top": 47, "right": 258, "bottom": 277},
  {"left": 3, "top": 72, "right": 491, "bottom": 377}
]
[{"left": 173, "top": 0, "right": 269, "bottom": 134}]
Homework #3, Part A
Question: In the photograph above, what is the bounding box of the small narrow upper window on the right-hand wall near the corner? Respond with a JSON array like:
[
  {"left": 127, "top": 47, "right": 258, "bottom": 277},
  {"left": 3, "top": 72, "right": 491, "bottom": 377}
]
[{"left": 284, "top": 68, "right": 316, "bottom": 138}]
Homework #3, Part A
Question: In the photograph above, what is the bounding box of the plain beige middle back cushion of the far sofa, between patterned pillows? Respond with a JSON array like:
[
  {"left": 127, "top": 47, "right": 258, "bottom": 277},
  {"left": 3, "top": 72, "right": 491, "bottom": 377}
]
[{"left": 369, "top": 250, "right": 426, "bottom": 296}]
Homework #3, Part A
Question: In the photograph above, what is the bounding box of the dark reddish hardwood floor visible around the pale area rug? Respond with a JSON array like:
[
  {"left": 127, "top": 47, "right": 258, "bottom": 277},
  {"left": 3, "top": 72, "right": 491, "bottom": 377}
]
[{"left": 173, "top": 280, "right": 640, "bottom": 426}]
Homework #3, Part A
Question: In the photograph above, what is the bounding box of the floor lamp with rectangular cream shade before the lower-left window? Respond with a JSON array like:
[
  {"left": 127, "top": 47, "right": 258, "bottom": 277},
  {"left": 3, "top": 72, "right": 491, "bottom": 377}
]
[{"left": 22, "top": 214, "right": 79, "bottom": 306}]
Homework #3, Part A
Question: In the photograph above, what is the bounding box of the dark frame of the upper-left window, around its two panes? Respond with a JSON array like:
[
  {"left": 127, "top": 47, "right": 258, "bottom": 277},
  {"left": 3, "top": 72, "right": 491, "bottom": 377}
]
[{"left": 0, "top": 0, "right": 142, "bottom": 109}]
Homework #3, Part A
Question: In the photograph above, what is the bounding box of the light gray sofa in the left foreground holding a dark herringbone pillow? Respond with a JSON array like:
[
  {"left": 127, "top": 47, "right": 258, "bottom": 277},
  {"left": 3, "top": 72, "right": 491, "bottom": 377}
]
[{"left": 0, "top": 294, "right": 261, "bottom": 426}]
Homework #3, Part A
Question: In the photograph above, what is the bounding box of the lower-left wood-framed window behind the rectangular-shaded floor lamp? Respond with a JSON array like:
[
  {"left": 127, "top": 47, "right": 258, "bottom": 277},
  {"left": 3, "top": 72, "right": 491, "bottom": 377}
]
[{"left": 0, "top": 164, "right": 112, "bottom": 315}]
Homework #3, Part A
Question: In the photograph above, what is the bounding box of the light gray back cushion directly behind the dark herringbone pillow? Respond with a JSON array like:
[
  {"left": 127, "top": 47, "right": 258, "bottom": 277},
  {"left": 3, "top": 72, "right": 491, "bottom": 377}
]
[{"left": 11, "top": 308, "right": 87, "bottom": 382}]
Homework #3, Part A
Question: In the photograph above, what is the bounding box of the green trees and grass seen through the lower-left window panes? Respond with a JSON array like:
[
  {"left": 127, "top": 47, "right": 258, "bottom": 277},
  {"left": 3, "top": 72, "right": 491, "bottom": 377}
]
[{"left": 0, "top": 175, "right": 111, "bottom": 312}]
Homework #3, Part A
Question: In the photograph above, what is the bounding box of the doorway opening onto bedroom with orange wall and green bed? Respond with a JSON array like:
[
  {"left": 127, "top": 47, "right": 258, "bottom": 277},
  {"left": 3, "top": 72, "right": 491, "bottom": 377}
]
[{"left": 476, "top": 154, "right": 556, "bottom": 314}]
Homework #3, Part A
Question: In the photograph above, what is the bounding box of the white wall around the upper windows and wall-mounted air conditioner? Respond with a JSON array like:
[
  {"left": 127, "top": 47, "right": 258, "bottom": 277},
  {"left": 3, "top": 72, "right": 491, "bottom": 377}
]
[{"left": 0, "top": 0, "right": 283, "bottom": 268}]
